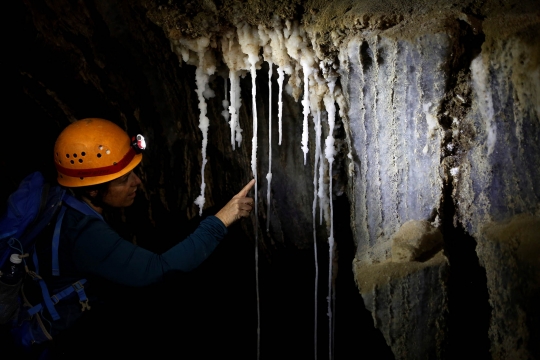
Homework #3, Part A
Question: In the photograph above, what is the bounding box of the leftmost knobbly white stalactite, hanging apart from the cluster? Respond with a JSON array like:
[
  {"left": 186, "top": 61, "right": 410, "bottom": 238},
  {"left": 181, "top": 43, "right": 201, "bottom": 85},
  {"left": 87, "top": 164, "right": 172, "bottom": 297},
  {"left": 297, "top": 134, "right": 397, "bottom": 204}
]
[{"left": 179, "top": 37, "right": 216, "bottom": 216}]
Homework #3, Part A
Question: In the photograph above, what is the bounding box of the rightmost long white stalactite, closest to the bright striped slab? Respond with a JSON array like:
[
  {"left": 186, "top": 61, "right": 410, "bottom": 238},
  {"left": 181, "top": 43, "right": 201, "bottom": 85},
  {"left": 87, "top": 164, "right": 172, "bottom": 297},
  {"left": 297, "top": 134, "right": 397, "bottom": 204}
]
[{"left": 324, "top": 81, "right": 336, "bottom": 359}]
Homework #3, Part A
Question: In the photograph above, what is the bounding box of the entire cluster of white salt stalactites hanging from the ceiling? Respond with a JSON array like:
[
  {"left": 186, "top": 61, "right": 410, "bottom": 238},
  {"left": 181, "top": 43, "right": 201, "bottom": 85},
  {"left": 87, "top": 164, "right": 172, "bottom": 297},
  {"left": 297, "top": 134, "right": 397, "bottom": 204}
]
[{"left": 172, "top": 18, "right": 342, "bottom": 358}]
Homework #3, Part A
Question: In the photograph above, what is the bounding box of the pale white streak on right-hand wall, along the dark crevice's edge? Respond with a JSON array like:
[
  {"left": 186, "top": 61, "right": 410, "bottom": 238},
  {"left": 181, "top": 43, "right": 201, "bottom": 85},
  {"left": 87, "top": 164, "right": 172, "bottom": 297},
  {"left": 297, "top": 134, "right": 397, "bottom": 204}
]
[{"left": 471, "top": 54, "right": 497, "bottom": 155}]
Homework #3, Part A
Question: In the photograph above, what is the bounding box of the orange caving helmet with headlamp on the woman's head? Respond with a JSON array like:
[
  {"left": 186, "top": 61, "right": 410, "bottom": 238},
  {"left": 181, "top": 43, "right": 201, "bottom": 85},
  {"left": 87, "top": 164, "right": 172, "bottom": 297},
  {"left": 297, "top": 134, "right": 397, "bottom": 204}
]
[{"left": 54, "top": 119, "right": 145, "bottom": 187}]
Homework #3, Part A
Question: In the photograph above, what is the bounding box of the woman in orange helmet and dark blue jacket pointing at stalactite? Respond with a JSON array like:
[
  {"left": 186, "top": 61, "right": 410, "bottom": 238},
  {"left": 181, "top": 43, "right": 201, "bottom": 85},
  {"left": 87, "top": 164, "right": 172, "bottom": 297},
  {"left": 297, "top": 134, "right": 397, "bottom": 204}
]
[{"left": 22, "top": 119, "right": 255, "bottom": 358}]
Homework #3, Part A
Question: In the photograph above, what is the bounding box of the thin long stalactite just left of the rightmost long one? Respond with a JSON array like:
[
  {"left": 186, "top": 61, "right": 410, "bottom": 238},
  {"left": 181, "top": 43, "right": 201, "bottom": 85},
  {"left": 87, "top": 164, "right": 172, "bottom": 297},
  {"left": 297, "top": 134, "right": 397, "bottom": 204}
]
[{"left": 312, "top": 106, "right": 322, "bottom": 360}]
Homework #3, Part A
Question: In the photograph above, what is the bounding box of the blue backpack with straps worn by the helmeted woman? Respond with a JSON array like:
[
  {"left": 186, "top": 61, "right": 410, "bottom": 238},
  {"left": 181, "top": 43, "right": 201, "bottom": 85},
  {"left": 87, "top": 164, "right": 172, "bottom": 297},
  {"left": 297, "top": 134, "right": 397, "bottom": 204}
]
[{"left": 0, "top": 172, "right": 103, "bottom": 349}]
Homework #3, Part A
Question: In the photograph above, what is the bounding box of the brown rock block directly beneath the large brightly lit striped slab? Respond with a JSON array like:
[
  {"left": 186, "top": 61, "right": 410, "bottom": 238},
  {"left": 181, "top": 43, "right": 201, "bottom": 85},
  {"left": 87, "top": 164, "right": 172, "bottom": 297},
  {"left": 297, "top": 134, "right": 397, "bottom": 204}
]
[{"left": 353, "top": 251, "right": 449, "bottom": 359}]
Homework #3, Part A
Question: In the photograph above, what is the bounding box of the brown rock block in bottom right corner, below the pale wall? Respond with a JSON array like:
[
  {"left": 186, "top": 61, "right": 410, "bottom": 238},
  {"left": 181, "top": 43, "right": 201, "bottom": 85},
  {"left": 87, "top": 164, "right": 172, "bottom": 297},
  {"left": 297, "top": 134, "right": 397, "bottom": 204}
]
[{"left": 476, "top": 214, "right": 540, "bottom": 359}]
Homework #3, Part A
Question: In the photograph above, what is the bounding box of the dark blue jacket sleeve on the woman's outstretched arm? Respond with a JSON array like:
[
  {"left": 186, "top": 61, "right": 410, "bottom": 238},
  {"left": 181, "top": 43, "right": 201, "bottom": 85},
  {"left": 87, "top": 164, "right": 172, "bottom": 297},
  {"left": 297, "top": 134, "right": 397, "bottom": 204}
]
[{"left": 66, "top": 216, "right": 227, "bottom": 286}]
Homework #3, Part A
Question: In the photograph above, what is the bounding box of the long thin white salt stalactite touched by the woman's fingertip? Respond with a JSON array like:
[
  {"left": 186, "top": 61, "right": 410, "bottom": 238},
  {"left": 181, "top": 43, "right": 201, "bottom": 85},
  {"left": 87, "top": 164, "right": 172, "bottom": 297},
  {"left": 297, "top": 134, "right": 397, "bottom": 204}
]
[{"left": 238, "top": 24, "right": 261, "bottom": 359}]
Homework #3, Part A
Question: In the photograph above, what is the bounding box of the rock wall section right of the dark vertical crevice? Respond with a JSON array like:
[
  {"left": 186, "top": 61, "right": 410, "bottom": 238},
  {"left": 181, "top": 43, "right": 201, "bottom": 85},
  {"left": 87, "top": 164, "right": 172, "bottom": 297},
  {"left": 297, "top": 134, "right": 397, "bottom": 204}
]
[{"left": 454, "top": 19, "right": 540, "bottom": 359}]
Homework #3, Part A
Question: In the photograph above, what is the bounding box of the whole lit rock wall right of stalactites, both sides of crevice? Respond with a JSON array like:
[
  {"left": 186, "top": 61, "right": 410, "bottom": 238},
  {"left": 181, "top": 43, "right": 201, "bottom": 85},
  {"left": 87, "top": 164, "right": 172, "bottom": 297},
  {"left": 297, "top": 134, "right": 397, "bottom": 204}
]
[{"left": 342, "top": 3, "right": 540, "bottom": 359}]
